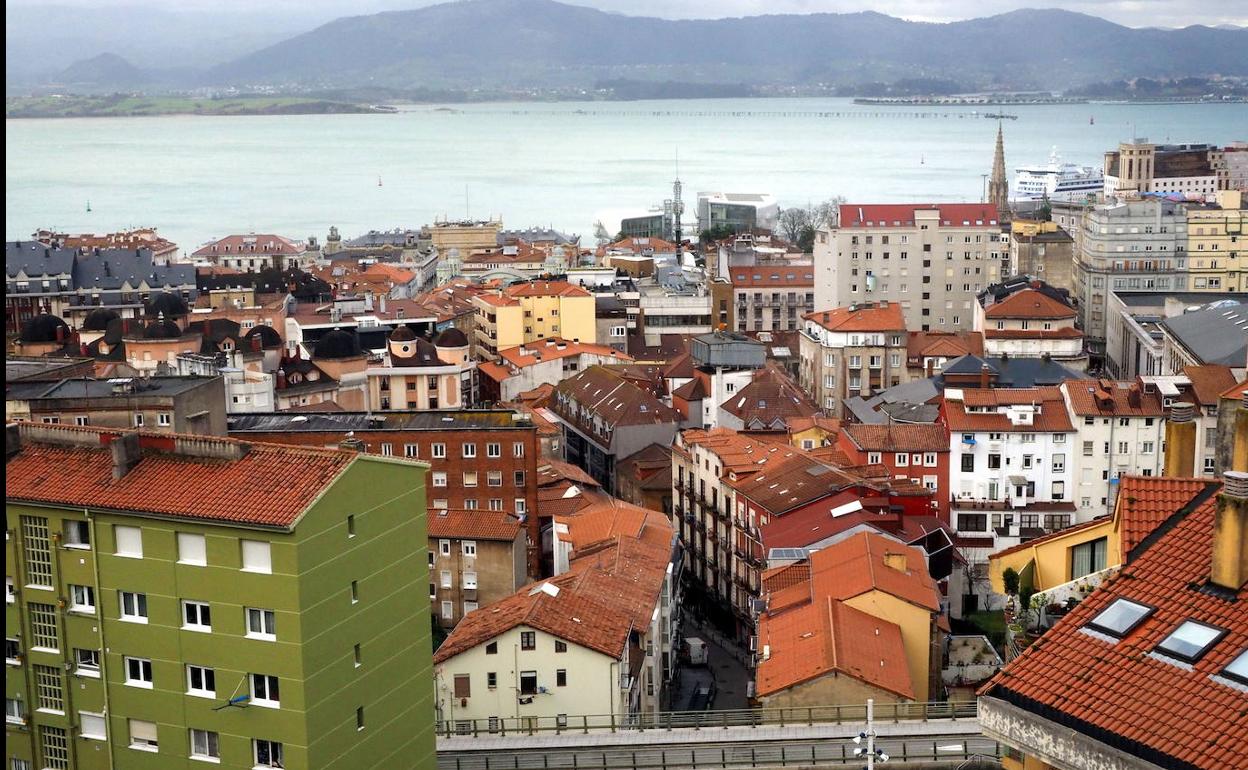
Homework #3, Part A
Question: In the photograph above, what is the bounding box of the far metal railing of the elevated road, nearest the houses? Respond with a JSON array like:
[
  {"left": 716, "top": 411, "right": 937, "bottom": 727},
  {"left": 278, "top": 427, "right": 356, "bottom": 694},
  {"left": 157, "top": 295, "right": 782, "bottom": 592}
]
[{"left": 437, "top": 701, "right": 978, "bottom": 738}]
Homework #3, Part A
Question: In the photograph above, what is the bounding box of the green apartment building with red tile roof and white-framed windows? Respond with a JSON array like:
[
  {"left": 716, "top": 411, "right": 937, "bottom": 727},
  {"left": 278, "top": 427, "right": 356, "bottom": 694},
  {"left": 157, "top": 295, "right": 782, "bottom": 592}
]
[{"left": 5, "top": 423, "right": 437, "bottom": 770}]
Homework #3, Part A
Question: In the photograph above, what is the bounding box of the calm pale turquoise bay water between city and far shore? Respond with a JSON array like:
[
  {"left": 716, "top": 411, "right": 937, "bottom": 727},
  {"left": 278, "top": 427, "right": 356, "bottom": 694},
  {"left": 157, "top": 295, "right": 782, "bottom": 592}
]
[{"left": 5, "top": 99, "right": 1248, "bottom": 248}]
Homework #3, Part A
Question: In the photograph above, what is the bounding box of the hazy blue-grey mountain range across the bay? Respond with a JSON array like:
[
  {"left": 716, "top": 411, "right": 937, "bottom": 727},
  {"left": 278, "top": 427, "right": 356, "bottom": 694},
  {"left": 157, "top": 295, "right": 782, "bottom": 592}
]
[{"left": 10, "top": 0, "right": 1248, "bottom": 91}]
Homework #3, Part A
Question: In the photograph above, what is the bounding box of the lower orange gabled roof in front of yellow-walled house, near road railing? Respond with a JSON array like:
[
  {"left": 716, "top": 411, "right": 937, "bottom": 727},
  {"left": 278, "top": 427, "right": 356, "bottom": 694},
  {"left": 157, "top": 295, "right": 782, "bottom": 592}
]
[{"left": 755, "top": 598, "right": 915, "bottom": 700}]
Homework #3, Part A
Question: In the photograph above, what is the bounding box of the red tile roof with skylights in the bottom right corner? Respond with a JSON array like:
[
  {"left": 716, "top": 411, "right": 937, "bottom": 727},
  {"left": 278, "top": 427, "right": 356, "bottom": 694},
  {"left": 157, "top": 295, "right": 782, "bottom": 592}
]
[{"left": 980, "top": 479, "right": 1248, "bottom": 770}]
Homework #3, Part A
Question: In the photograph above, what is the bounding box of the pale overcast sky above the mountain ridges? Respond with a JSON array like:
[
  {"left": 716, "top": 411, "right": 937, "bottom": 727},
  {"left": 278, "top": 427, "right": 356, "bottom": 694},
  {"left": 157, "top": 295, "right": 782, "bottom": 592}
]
[{"left": 6, "top": 0, "right": 1248, "bottom": 27}]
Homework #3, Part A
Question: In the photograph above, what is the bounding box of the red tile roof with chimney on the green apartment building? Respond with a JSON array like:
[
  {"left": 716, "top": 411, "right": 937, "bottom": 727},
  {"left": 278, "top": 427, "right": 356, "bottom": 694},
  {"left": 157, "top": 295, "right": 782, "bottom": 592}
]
[{"left": 5, "top": 424, "right": 362, "bottom": 528}]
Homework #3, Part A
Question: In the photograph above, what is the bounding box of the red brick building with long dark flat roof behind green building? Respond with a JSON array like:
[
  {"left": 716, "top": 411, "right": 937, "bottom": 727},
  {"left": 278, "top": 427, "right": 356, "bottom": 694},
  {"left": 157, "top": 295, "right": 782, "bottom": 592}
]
[{"left": 228, "top": 409, "right": 540, "bottom": 579}]
